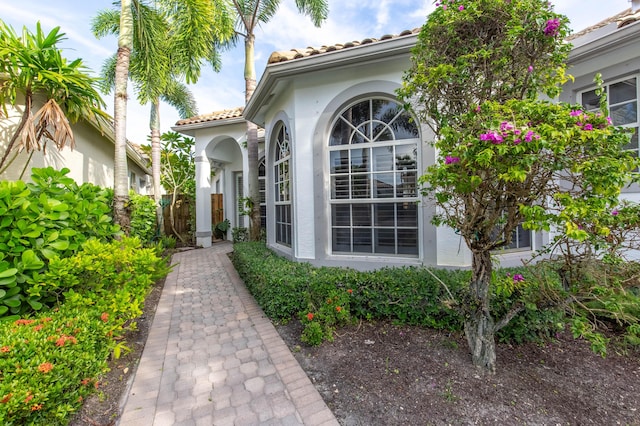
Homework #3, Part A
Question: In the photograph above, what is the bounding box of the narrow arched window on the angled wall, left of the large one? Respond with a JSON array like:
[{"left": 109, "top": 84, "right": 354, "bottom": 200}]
[{"left": 273, "top": 125, "right": 291, "bottom": 247}]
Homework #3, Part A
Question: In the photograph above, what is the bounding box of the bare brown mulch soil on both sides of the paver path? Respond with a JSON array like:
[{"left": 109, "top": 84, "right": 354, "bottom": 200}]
[{"left": 70, "top": 268, "right": 640, "bottom": 426}]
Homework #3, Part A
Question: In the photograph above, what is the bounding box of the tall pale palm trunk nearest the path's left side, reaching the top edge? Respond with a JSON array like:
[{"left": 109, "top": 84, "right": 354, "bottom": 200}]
[{"left": 113, "top": 0, "right": 133, "bottom": 235}]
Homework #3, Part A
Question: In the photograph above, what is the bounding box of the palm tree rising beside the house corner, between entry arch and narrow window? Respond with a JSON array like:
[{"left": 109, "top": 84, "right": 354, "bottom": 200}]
[{"left": 233, "top": 0, "right": 329, "bottom": 241}]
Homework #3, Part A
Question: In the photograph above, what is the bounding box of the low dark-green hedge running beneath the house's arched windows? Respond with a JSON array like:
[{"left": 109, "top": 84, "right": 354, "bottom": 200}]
[{"left": 232, "top": 242, "right": 640, "bottom": 352}]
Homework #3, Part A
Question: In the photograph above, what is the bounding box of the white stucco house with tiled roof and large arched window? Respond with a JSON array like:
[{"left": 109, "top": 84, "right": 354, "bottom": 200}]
[{"left": 173, "top": 3, "right": 640, "bottom": 269}]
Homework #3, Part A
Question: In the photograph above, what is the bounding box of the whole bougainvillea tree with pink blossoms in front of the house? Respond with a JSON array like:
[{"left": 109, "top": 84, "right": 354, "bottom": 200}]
[{"left": 399, "top": 0, "right": 635, "bottom": 372}]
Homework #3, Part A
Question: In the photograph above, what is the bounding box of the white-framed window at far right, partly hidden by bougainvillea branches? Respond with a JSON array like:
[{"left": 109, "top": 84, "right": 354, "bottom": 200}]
[{"left": 581, "top": 76, "right": 640, "bottom": 155}]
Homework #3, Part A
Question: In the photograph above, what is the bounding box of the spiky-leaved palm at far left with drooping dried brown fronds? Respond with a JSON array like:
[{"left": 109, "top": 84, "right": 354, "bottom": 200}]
[{"left": 0, "top": 21, "right": 108, "bottom": 173}]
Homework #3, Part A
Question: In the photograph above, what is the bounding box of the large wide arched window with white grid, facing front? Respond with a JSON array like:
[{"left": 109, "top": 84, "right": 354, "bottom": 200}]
[{"left": 329, "top": 98, "right": 419, "bottom": 256}]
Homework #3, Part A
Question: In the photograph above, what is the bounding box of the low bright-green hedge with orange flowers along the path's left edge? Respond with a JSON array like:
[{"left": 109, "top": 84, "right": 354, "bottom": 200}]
[{"left": 0, "top": 238, "right": 167, "bottom": 425}]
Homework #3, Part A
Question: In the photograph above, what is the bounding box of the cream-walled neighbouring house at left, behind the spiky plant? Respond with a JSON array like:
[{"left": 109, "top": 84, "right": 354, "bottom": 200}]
[{"left": 0, "top": 95, "right": 153, "bottom": 195}]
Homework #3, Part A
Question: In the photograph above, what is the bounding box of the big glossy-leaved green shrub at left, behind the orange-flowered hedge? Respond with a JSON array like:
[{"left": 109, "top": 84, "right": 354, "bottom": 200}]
[{"left": 0, "top": 167, "right": 118, "bottom": 317}]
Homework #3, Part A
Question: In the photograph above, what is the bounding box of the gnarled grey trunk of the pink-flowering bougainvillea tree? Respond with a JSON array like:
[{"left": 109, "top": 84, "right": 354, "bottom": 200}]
[{"left": 464, "top": 250, "right": 496, "bottom": 373}]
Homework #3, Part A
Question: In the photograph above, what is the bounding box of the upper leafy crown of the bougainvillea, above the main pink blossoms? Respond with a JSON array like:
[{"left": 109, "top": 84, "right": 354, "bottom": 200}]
[{"left": 399, "top": 0, "right": 571, "bottom": 131}]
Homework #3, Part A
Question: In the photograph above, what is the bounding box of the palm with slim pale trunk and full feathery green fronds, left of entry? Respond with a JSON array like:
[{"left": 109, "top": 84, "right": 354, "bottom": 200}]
[{"left": 92, "top": 0, "right": 234, "bottom": 235}]
